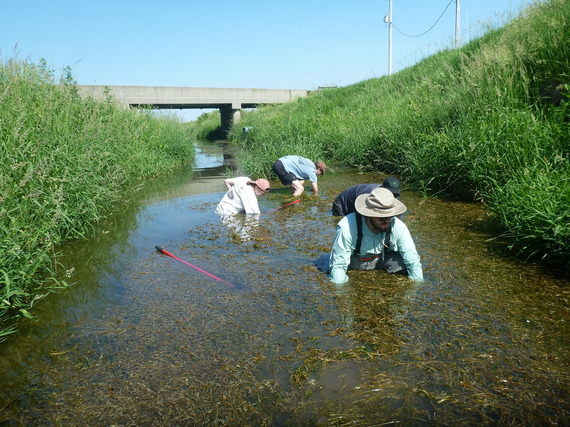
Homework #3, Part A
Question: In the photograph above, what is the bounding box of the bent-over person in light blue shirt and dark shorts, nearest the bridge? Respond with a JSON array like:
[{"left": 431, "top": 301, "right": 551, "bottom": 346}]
[{"left": 273, "top": 156, "right": 327, "bottom": 196}]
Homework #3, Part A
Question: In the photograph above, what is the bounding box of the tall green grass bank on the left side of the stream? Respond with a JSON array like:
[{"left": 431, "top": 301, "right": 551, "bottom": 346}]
[{"left": 0, "top": 59, "right": 194, "bottom": 340}]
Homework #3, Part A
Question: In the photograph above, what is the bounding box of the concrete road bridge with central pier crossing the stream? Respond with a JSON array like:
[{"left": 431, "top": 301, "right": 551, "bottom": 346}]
[{"left": 77, "top": 85, "right": 309, "bottom": 133}]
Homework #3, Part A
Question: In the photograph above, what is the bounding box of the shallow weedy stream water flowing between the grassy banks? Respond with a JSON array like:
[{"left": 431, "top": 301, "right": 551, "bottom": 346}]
[{"left": 0, "top": 144, "right": 570, "bottom": 425}]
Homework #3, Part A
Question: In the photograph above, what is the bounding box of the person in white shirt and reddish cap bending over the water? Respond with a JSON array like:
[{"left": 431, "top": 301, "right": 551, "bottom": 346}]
[{"left": 216, "top": 176, "right": 269, "bottom": 215}]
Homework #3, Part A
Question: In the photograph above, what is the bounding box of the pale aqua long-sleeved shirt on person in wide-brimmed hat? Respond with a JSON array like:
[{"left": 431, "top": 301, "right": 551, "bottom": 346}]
[{"left": 329, "top": 213, "right": 424, "bottom": 284}]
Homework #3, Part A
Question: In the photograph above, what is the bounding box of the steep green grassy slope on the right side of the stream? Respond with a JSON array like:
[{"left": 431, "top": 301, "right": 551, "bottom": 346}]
[{"left": 189, "top": 0, "right": 570, "bottom": 273}]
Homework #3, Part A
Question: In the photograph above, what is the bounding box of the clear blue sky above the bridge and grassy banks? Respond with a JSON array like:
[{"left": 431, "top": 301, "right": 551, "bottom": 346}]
[{"left": 0, "top": 0, "right": 534, "bottom": 119}]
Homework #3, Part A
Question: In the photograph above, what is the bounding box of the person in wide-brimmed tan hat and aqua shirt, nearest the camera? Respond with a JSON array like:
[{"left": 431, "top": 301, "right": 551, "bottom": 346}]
[{"left": 329, "top": 188, "right": 423, "bottom": 284}]
